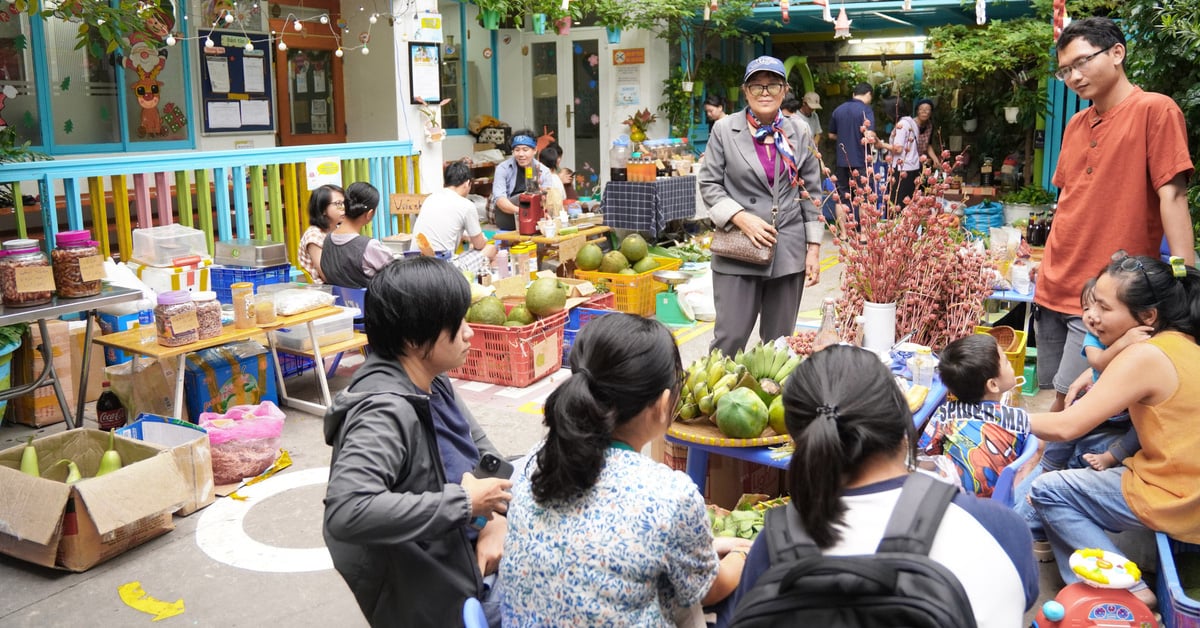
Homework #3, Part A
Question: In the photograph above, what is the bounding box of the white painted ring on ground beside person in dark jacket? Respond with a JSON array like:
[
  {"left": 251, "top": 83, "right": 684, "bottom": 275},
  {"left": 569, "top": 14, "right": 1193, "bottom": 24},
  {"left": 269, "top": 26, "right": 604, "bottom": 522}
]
[{"left": 196, "top": 467, "right": 334, "bottom": 574}]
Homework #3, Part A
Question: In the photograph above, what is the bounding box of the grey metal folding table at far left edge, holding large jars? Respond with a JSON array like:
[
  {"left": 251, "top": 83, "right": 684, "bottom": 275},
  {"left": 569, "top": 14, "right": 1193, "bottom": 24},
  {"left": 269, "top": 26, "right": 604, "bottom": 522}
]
[{"left": 0, "top": 283, "right": 142, "bottom": 429}]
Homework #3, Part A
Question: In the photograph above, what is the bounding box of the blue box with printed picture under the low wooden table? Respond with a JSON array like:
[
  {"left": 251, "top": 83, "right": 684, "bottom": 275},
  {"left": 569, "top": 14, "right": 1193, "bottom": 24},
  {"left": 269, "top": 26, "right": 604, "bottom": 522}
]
[{"left": 184, "top": 341, "right": 280, "bottom": 423}]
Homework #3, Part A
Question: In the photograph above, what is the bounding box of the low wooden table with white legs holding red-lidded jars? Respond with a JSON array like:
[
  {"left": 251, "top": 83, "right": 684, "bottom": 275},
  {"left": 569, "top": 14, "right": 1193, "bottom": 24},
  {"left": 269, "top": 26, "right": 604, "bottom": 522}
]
[{"left": 95, "top": 305, "right": 342, "bottom": 418}]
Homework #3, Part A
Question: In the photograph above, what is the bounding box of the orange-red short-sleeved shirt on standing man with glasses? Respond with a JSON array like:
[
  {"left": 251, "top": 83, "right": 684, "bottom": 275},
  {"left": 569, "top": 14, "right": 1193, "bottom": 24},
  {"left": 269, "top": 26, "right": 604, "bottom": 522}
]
[{"left": 1034, "top": 88, "right": 1192, "bottom": 316}]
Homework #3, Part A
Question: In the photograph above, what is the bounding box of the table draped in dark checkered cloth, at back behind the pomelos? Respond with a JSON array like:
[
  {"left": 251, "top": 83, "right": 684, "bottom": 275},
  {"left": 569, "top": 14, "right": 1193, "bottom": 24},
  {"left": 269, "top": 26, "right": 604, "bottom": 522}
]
[{"left": 600, "top": 174, "right": 696, "bottom": 238}]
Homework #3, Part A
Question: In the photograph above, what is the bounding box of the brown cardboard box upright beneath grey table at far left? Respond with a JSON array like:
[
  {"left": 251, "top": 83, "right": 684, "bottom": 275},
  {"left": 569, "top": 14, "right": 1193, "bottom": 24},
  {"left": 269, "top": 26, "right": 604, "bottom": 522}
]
[{"left": 8, "top": 321, "right": 76, "bottom": 427}]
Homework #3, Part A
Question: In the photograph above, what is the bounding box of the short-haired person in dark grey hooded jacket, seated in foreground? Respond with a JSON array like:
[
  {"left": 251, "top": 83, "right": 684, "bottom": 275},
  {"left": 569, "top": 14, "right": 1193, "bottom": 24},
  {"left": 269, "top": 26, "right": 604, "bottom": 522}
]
[{"left": 324, "top": 257, "right": 511, "bottom": 627}]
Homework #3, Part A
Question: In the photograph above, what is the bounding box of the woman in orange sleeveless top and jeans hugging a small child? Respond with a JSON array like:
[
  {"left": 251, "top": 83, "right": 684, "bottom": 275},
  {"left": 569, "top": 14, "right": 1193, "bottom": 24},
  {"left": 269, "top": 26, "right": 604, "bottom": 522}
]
[{"left": 1030, "top": 251, "right": 1200, "bottom": 605}]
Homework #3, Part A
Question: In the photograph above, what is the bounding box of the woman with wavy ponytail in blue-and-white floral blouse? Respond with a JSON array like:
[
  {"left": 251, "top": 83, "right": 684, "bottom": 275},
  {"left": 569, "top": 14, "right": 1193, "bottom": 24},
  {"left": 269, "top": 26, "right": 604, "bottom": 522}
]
[{"left": 500, "top": 313, "right": 749, "bottom": 626}]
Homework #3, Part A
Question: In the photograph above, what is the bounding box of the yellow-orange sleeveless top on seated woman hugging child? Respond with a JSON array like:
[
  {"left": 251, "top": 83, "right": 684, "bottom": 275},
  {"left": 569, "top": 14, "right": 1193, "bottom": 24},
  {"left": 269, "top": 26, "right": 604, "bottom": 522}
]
[{"left": 1121, "top": 331, "right": 1200, "bottom": 543}]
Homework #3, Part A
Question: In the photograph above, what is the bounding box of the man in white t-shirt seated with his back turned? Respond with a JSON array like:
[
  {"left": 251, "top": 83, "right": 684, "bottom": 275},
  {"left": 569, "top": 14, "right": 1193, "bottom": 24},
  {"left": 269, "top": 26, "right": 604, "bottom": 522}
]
[{"left": 413, "top": 161, "right": 496, "bottom": 273}]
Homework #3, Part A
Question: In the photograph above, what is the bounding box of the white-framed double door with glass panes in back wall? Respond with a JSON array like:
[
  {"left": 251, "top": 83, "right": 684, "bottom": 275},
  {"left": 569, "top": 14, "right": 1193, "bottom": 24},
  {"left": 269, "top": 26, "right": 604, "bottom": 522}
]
[{"left": 527, "top": 33, "right": 605, "bottom": 199}]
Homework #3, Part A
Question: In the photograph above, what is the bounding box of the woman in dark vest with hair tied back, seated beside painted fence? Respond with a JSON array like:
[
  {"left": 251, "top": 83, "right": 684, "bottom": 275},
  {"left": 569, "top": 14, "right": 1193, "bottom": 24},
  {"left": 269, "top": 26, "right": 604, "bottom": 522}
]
[{"left": 320, "top": 181, "right": 395, "bottom": 288}]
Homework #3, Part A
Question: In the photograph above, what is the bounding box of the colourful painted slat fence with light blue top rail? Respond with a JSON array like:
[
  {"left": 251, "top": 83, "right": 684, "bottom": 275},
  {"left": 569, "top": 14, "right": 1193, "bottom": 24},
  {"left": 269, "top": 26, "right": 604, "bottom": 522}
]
[{"left": 0, "top": 142, "right": 420, "bottom": 271}]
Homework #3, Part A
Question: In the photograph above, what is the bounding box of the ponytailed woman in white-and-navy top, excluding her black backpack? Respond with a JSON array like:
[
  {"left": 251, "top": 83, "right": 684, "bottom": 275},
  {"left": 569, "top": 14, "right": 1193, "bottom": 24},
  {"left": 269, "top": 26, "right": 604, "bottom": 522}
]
[{"left": 718, "top": 346, "right": 1038, "bottom": 628}]
